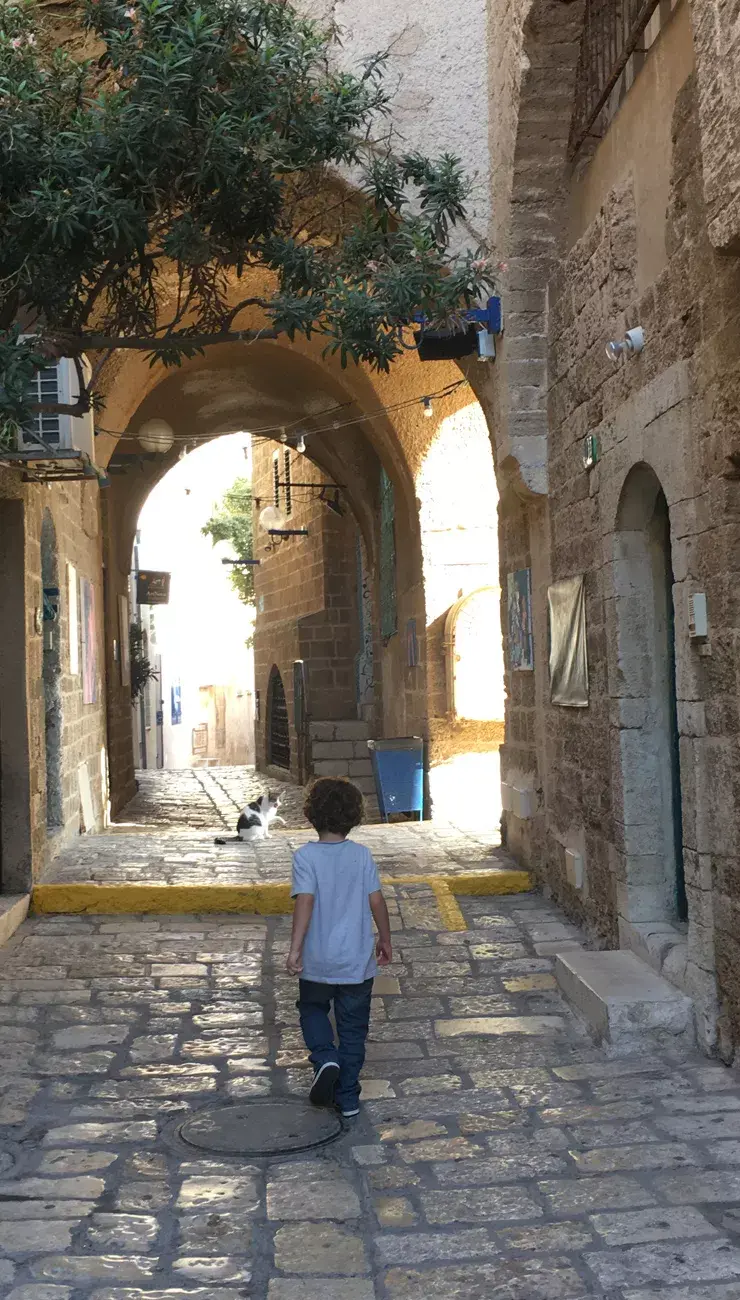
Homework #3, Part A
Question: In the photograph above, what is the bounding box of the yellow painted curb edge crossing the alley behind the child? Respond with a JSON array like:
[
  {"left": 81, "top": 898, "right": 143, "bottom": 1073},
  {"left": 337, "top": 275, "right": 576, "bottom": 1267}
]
[{"left": 30, "top": 870, "right": 531, "bottom": 930}]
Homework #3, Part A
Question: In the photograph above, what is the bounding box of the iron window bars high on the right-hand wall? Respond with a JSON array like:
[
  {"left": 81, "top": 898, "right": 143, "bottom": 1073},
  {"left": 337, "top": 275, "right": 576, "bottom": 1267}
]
[{"left": 570, "top": 0, "right": 661, "bottom": 157}]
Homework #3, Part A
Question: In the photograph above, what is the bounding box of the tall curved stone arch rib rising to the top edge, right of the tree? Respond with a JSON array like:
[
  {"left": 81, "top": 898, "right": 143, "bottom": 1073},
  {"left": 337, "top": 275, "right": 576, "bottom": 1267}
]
[{"left": 492, "top": 0, "right": 584, "bottom": 497}]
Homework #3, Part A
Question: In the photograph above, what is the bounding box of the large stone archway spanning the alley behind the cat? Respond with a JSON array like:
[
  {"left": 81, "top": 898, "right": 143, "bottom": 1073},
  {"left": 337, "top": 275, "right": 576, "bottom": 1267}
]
[{"left": 94, "top": 341, "right": 436, "bottom": 815}]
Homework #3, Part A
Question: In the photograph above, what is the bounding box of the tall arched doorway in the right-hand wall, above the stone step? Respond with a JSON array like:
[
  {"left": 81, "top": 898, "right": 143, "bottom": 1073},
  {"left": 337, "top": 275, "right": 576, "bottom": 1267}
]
[{"left": 613, "top": 464, "right": 687, "bottom": 923}]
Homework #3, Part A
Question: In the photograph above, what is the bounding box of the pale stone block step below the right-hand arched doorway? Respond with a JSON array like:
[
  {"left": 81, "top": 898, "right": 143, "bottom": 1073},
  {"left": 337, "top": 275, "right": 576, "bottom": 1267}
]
[{"left": 555, "top": 949, "right": 693, "bottom": 1054}]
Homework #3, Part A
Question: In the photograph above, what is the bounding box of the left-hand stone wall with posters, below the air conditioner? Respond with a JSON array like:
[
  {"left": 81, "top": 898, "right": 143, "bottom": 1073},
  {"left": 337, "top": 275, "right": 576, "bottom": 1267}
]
[{"left": 0, "top": 469, "right": 108, "bottom": 892}]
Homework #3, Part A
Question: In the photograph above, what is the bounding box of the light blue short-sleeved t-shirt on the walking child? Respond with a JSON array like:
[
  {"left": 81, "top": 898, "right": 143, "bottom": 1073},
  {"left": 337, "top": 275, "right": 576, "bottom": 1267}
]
[{"left": 291, "top": 840, "right": 380, "bottom": 984}]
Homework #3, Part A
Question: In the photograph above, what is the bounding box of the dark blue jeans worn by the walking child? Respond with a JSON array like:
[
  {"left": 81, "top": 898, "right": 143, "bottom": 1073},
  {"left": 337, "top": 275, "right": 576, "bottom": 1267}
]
[{"left": 295, "top": 979, "right": 373, "bottom": 1110}]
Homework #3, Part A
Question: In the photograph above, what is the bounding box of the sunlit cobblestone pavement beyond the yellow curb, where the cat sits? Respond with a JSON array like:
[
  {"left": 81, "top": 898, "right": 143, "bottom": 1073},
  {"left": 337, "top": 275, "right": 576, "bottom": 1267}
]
[{"left": 44, "top": 767, "right": 502, "bottom": 884}]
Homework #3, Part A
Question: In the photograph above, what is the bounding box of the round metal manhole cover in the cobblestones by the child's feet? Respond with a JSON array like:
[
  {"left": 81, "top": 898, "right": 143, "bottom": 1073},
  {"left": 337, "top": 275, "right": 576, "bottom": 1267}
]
[{"left": 179, "top": 1099, "right": 342, "bottom": 1156}]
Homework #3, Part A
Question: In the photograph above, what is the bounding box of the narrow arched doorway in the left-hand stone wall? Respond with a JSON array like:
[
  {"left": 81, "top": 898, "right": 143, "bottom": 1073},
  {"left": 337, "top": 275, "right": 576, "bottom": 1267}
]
[{"left": 42, "top": 510, "right": 64, "bottom": 832}]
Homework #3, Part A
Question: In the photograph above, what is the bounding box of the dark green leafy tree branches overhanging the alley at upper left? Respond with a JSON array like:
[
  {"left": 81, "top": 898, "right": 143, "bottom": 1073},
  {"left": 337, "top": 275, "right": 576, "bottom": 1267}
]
[{"left": 0, "top": 0, "right": 493, "bottom": 439}]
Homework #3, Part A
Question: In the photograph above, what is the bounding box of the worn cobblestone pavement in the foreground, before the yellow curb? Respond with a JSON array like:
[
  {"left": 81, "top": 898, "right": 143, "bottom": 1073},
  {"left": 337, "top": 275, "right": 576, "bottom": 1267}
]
[{"left": 0, "top": 885, "right": 740, "bottom": 1300}]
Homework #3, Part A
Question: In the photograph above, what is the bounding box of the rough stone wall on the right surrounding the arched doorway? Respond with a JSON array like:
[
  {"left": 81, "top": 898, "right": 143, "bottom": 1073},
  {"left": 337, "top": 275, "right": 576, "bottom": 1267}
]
[{"left": 501, "top": 20, "right": 740, "bottom": 1057}]
